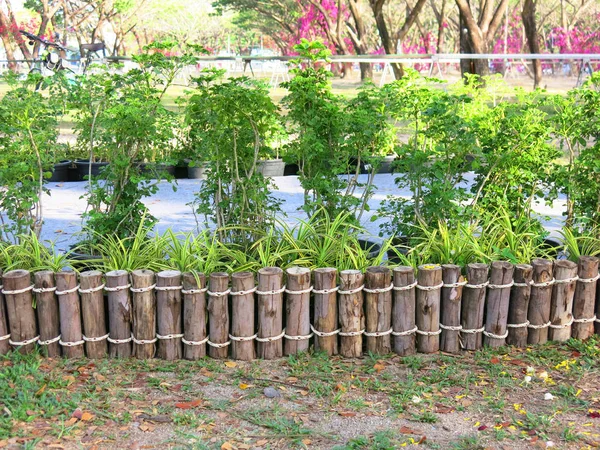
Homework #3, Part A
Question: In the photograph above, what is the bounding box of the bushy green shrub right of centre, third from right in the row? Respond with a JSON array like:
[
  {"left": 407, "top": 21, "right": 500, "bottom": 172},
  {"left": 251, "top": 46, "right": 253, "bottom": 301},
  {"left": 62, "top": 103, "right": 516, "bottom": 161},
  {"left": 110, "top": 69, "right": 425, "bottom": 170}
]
[{"left": 373, "top": 71, "right": 478, "bottom": 236}]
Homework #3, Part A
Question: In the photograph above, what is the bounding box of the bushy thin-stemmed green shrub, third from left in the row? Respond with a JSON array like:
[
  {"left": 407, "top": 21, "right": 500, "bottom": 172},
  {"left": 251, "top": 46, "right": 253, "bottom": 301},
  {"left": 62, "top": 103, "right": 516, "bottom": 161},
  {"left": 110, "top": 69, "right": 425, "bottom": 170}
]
[{"left": 186, "top": 70, "right": 282, "bottom": 243}]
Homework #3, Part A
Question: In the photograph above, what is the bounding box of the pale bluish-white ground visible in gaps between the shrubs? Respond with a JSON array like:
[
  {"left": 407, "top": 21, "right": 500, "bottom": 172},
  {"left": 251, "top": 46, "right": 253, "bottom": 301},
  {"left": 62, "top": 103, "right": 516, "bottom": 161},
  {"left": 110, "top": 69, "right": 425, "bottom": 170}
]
[{"left": 42, "top": 174, "right": 565, "bottom": 250}]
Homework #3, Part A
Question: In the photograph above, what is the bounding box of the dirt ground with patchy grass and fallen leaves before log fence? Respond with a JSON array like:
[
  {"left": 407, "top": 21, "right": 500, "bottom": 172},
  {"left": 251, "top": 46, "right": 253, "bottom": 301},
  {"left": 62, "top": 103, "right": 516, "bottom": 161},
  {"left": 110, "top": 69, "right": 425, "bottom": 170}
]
[{"left": 0, "top": 336, "right": 600, "bottom": 450}]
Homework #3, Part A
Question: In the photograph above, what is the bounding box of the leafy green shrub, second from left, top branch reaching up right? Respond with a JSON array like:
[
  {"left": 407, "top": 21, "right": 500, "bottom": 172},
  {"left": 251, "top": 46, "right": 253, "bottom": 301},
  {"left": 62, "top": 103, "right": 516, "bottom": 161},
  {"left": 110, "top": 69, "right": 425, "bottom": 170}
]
[{"left": 69, "top": 43, "right": 202, "bottom": 253}]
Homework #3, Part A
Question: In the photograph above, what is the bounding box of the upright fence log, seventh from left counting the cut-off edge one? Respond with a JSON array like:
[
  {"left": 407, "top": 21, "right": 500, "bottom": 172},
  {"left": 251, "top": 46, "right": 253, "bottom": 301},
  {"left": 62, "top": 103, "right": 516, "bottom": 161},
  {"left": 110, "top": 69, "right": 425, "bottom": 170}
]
[{"left": 131, "top": 269, "right": 157, "bottom": 359}]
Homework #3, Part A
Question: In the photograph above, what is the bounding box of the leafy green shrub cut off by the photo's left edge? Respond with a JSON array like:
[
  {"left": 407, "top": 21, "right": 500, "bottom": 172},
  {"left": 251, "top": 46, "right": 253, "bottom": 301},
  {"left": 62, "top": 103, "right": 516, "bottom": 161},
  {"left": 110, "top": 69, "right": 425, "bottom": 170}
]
[{"left": 0, "top": 73, "right": 63, "bottom": 242}]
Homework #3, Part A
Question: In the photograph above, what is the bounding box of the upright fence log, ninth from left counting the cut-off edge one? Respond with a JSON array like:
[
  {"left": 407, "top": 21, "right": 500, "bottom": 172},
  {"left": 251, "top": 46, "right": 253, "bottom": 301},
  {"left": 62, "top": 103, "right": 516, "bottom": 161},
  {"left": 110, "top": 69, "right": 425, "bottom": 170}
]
[{"left": 181, "top": 272, "right": 208, "bottom": 361}]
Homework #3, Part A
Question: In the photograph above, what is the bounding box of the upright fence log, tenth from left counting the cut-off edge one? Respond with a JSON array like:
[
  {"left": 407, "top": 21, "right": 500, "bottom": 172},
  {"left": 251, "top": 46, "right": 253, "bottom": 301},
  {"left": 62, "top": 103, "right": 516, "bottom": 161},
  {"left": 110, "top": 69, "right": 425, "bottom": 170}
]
[{"left": 207, "top": 272, "right": 230, "bottom": 359}]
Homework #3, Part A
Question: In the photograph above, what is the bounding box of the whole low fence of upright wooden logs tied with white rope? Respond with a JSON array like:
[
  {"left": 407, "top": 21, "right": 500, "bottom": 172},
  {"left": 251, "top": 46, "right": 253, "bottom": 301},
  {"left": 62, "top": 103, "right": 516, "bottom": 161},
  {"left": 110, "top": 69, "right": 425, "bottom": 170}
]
[{"left": 0, "top": 257, "right": 600, "bottom": 361}]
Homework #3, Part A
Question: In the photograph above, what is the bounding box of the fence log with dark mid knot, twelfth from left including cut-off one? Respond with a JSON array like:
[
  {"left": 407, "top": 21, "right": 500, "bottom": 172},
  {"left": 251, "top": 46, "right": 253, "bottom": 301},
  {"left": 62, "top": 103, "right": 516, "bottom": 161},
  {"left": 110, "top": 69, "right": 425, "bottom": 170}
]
[{"left": 256, "top": 267, "right": 283, "bottom": 359}]
